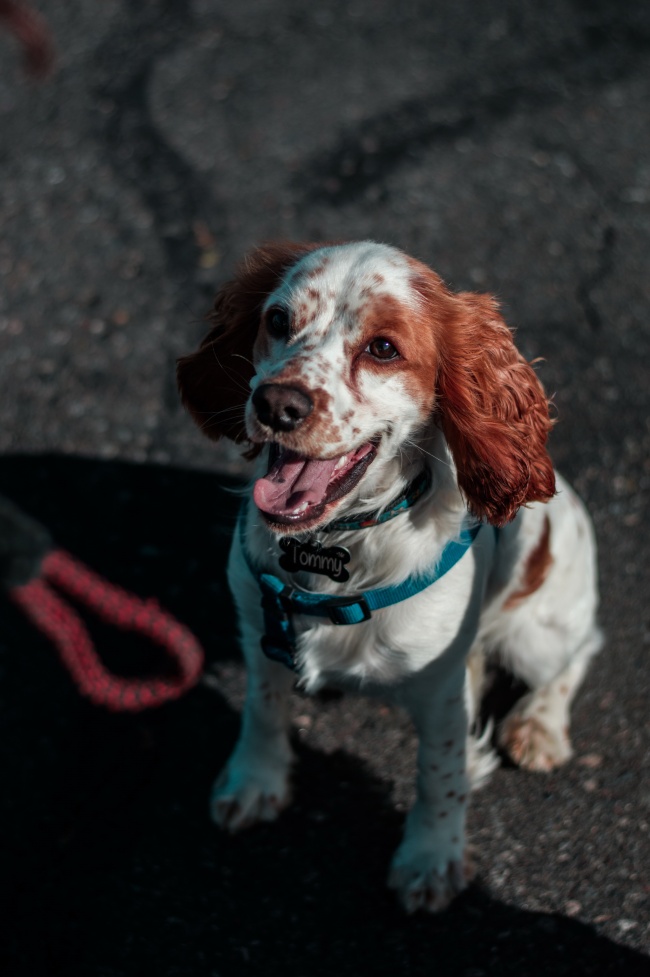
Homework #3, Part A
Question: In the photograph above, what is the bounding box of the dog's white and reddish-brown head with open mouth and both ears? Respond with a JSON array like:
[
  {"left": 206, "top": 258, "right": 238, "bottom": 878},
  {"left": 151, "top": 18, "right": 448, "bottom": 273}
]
[{"left": 178, "top": 241, "right": 555, "bottom": 533}]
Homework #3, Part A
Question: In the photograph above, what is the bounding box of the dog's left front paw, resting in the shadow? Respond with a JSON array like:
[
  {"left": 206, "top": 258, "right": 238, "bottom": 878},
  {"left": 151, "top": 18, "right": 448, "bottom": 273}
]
[{"left": 210, "top": 761, "right": 291, "bottom": 833}]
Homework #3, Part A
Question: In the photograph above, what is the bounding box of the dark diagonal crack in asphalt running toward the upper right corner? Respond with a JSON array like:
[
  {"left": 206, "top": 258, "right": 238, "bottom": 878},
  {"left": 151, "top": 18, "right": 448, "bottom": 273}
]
[{"left": 296, "top": 13, "right": 650, "bottom": 205}]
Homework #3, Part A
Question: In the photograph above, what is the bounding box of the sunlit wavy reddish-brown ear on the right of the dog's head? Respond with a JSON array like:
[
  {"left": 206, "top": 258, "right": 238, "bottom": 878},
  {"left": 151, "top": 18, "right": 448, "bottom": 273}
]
[{"left": 437, "top": 292, "right": 555, "bottom": 526}]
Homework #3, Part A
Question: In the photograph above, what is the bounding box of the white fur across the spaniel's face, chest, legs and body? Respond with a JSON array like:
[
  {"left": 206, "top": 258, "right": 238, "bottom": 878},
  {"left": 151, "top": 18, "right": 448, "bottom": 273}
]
[{"left": 204, "top": 242, "right": 601, "bottom": 911}]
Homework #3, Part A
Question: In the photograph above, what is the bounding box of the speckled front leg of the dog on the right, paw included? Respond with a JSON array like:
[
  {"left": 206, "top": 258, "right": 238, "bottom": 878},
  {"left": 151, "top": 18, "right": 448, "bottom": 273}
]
[{"left": 388, "top": 665, "right": 469, "bottom": 912}]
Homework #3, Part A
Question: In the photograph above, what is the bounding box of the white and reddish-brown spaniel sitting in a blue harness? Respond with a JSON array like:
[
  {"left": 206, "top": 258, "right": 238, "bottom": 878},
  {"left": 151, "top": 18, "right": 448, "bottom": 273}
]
[{"left": 178, "top": 241, "right": 602, "bottom": 912}]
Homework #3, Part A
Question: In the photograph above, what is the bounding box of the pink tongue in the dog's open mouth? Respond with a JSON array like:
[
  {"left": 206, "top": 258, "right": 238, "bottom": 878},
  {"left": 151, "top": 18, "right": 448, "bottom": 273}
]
[{"left": 253, "top": 451, "right": 339, "bottom": 516}]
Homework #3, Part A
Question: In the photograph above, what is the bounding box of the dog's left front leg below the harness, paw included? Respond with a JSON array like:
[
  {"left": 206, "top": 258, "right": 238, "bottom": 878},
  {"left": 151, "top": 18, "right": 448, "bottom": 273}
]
[{"left": 210, "top": 590, "right": 294, "bottom": 831}]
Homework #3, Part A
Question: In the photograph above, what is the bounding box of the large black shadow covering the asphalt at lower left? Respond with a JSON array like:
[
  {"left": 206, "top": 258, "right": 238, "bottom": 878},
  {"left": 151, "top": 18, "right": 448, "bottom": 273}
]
[{"left": 0, "top": 456, "right": 647, "bottom": 977}]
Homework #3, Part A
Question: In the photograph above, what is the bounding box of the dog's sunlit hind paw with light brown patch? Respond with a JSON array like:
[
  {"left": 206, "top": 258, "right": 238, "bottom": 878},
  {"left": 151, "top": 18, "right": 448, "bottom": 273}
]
[{"left": 499, "top": 710, "right": 572, "bottom": 773}]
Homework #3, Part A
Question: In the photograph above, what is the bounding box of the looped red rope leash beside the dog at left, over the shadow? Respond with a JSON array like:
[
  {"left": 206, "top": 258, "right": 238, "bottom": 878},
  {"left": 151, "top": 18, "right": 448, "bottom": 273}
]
[{"left": 9, "top": 549, "right": 203, "bottom": 712}]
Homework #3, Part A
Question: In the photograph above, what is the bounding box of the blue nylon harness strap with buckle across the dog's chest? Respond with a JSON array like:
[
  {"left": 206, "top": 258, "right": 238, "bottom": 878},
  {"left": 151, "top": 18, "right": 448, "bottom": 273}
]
[{"left": 239, "top": 503, "right": 481, "bottom": 670}]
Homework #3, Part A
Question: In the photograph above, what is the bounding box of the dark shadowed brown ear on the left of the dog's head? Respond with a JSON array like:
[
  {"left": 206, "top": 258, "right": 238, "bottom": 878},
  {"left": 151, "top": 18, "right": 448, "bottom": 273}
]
[{"left": 176, "top": 242, "right": 320, "bottom": 442}]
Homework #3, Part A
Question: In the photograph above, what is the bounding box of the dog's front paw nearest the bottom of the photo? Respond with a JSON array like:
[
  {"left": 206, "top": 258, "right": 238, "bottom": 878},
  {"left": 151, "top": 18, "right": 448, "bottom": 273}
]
[{"left": 388, "top": 849, "right": 472, "bottom": 913}]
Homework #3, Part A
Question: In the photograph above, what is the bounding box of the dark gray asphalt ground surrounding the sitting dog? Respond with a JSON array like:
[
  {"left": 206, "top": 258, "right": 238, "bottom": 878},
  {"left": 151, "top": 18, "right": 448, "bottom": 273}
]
[{"left": 0, "top": 0, "right": 650, "bottom": 977}]
